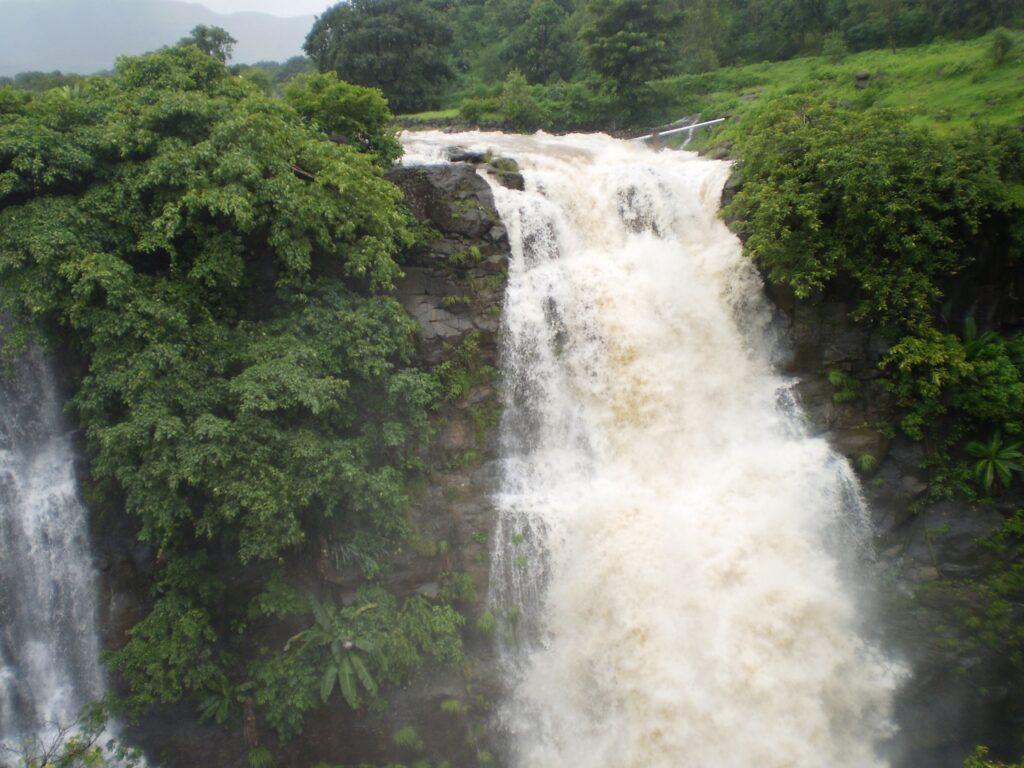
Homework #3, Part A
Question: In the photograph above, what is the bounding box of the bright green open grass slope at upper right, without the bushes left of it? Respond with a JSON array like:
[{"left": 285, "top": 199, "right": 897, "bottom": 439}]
[{"left": 655, "top": 31, "right": 1024, "bottom": 140}]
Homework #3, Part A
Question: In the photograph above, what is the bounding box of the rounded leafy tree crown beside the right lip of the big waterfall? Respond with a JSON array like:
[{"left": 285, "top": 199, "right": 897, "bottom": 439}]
[{"left": 729, "top": 97, "right": 1009, "bottom": 330}]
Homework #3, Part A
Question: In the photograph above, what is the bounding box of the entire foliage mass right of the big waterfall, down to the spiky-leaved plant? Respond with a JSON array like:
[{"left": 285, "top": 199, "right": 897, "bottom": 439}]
[{"left": 728, "top": 91, "right": 1024, "bottom": 493}]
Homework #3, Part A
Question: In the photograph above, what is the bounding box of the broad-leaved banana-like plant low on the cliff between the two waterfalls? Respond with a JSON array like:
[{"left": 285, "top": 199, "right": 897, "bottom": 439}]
[{"left": 285, "top": 595, "right": 378, "bottom": 710}]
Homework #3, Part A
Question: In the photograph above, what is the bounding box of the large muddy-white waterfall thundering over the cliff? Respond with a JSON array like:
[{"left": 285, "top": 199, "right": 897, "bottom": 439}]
[{"left": 404, "top": 133, "right": 900, "bottom": 768}]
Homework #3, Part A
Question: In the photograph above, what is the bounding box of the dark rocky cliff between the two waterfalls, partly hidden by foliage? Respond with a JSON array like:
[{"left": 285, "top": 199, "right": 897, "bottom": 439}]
[{"left": 95, "top": 157, "right": 509, "bottom": 768}]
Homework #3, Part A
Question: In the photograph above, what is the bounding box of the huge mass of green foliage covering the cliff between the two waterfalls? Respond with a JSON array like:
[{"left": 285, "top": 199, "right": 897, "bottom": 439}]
[{"left": 0, "top": 45, "right": 461, "bottom": 735}]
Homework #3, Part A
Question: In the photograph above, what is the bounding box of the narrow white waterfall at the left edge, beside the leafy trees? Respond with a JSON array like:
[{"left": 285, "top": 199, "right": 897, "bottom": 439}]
[{"left": 0, "top": 354, "right": 103, "bottom": 764}]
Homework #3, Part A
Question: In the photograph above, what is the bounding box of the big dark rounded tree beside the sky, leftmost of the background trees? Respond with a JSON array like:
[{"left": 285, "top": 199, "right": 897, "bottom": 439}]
[{"left": 303, "top": 0, "right": 455, "bottom": 113}]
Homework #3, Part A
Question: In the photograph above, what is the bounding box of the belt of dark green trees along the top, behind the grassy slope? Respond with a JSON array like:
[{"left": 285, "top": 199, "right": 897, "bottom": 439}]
[{"left": 323, "top": 0, "right": 1024, "bottom": 123}]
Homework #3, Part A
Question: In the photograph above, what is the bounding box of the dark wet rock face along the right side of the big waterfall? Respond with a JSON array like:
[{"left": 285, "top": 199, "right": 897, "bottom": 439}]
[{"left": 767, "top": 285, "right": 1024, "bottom": 768}]
